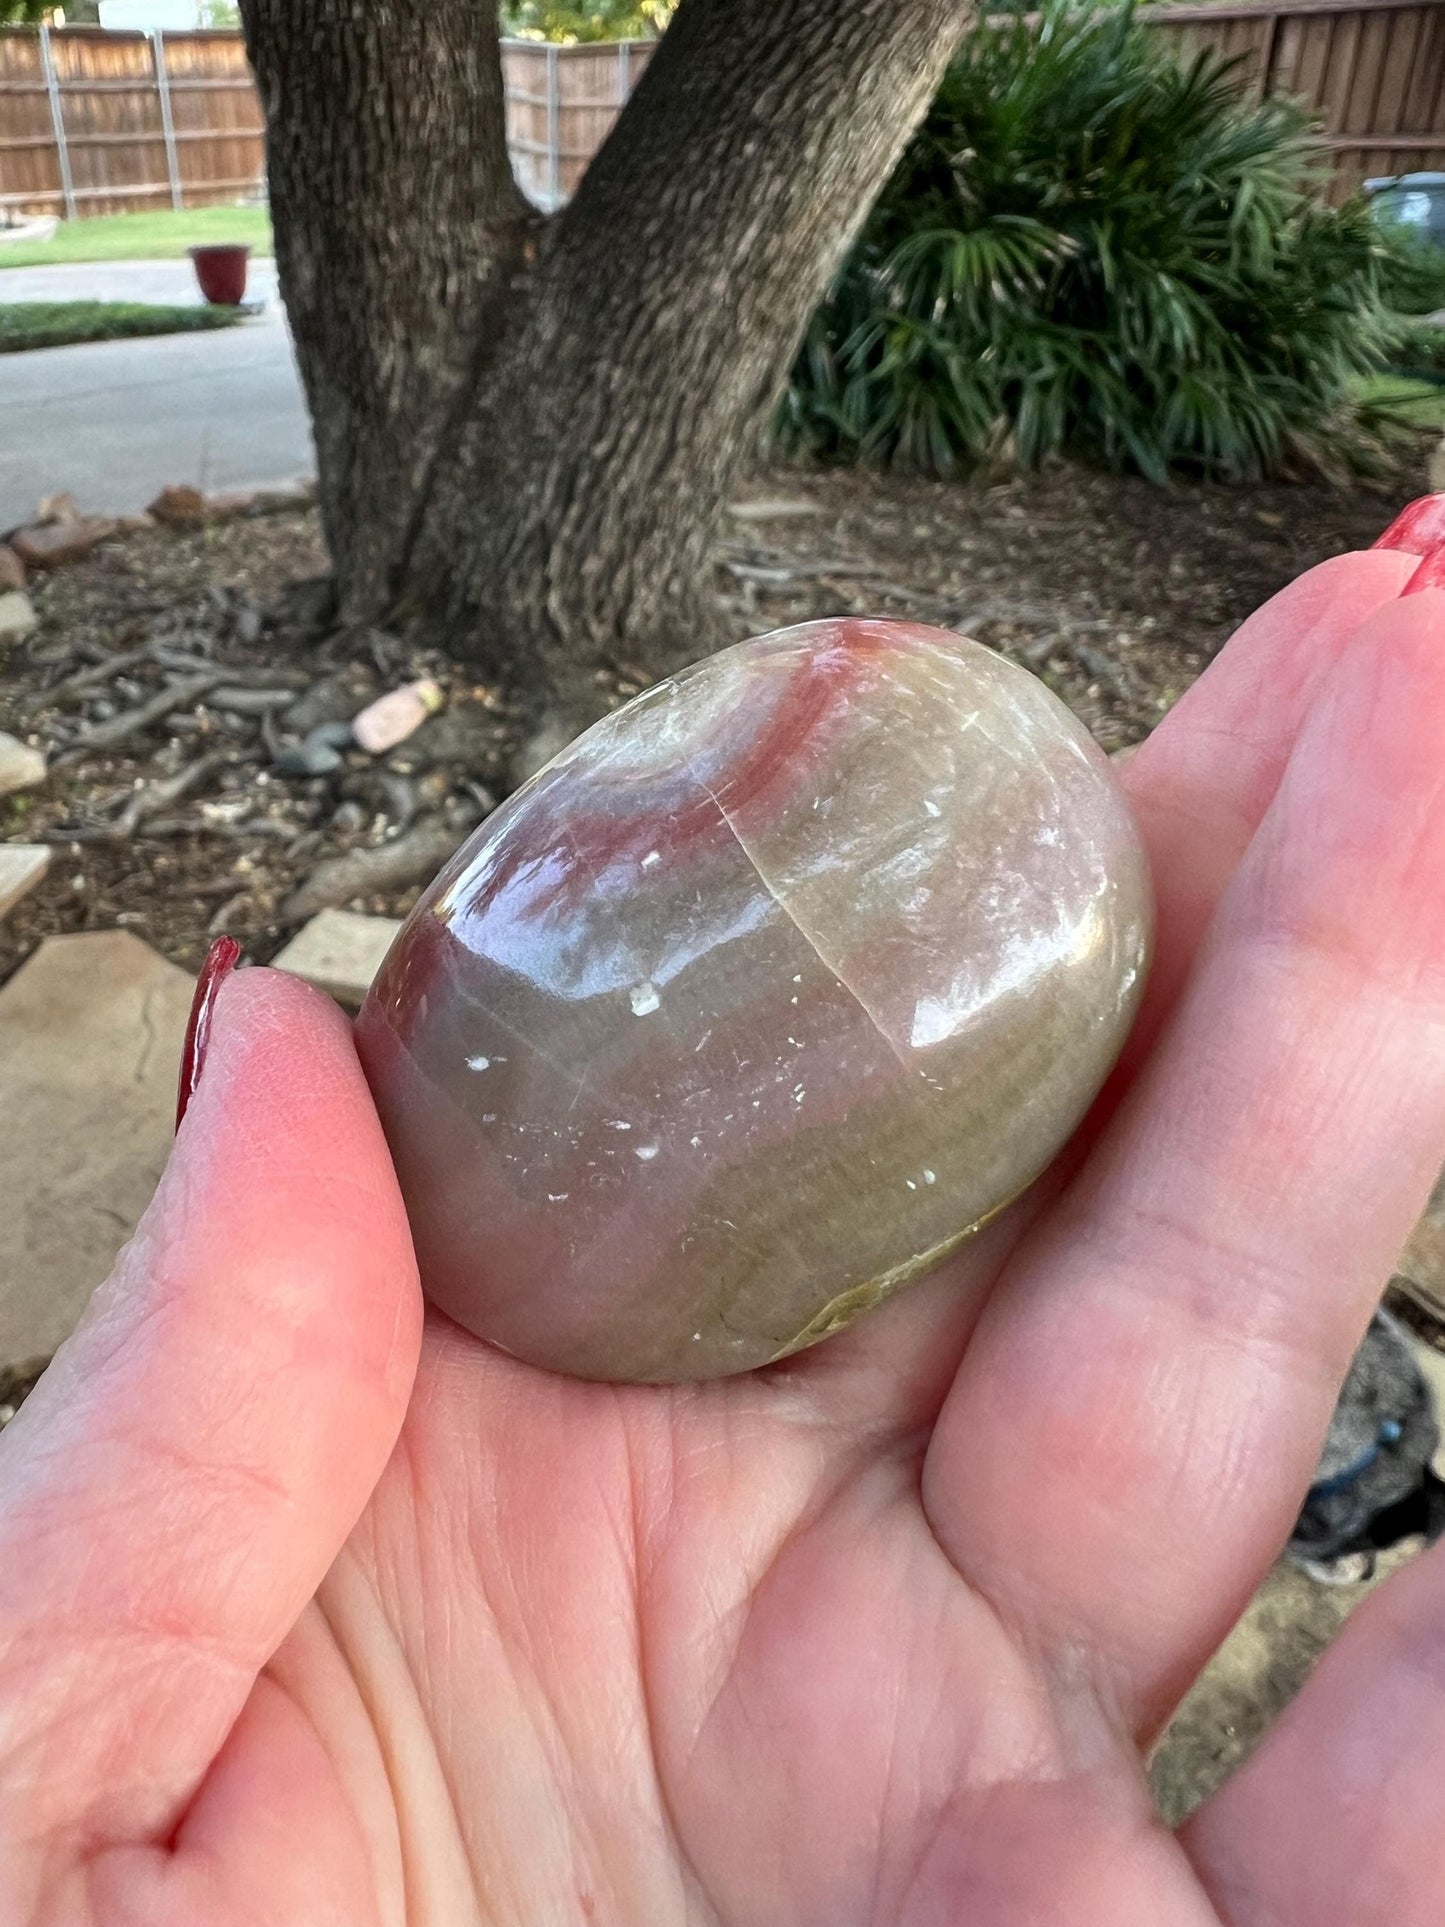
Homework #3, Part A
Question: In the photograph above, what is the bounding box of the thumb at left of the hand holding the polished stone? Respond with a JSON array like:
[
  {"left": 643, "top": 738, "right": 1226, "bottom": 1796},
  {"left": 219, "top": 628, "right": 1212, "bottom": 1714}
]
[{"left": 0, "top": 971, "right": 422, "bottom": 1850}]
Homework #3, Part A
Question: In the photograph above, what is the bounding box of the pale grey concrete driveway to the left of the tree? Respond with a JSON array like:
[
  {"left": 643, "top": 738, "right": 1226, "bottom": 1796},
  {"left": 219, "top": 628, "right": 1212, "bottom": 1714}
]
[{"left": 0, "top": 260, "right": 316, "bottom": 530}]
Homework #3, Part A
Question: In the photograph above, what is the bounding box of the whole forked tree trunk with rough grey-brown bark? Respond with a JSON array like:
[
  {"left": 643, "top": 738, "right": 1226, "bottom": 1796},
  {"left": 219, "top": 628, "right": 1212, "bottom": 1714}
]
[{"left": 243, "top": 0, "right": 971, "bottom": 715}]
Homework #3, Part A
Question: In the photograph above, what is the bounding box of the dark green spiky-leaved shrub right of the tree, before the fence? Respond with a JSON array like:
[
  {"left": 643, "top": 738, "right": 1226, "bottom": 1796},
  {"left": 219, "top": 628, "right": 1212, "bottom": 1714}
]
[{"left": 778, "top": 0, "right": 1399, "bottom": 480}]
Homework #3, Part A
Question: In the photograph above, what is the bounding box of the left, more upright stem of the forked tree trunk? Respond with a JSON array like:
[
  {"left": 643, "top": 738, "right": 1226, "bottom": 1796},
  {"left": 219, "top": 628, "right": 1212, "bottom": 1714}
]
[{"left": 241, "top": 0, "right": 539, "bottom": 620}]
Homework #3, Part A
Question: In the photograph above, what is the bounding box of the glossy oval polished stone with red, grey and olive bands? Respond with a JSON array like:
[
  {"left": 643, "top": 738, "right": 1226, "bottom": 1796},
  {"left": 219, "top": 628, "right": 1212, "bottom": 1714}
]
[{"left": 358, "top": 620, "right": 1150, "bottom": 1380}]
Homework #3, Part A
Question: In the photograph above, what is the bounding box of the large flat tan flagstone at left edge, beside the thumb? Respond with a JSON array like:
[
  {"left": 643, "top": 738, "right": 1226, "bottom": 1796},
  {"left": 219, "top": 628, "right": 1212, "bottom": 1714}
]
[{"left": 0, "top": 928, "right": 191, "bottom": 1366}]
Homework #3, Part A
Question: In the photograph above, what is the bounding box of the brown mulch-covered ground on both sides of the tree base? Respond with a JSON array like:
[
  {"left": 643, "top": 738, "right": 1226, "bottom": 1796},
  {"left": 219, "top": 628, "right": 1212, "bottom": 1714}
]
[{"left": 0, "top": 454, "right": 1424, "bottom": 981}]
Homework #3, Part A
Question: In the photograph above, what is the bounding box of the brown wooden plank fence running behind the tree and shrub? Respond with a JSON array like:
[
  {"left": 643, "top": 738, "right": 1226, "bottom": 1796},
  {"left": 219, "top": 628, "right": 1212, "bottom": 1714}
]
[{"left": 0, "top": 0, "right": 1445, "bottom": 216}]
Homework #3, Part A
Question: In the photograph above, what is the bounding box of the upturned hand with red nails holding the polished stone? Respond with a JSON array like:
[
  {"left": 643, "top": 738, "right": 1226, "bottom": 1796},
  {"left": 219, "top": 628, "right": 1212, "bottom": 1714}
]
[{"left": 0, "top": 551, "right": 1445, "bottom": 1927}]
